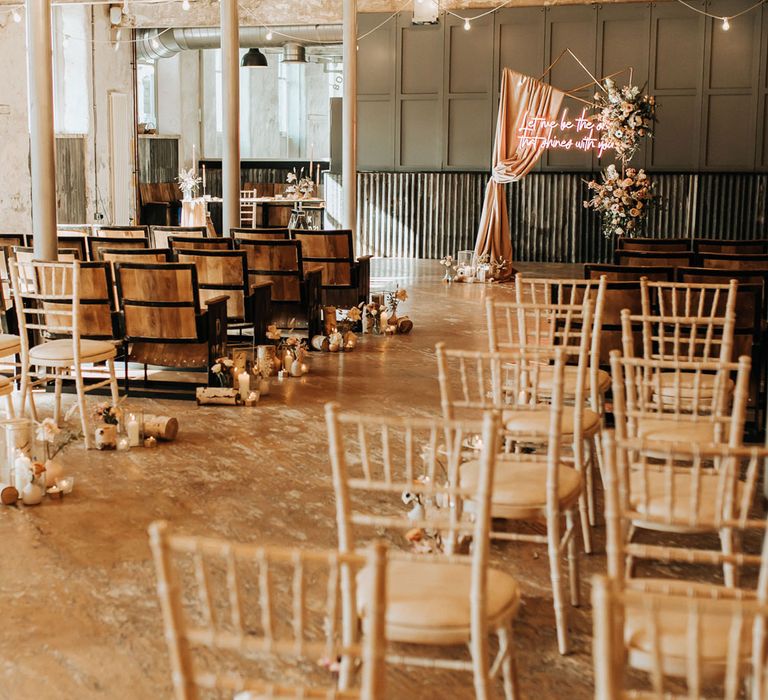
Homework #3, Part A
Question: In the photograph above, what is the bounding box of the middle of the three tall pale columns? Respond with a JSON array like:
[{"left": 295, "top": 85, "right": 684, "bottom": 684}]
[{"left": 220, "top": 0, "right": 240, "bottom": 236}]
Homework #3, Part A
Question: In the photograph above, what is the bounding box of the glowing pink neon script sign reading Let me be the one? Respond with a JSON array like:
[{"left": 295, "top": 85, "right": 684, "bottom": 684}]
[{"left": 518, "top": 107, "right": 608, "bottom": 158}]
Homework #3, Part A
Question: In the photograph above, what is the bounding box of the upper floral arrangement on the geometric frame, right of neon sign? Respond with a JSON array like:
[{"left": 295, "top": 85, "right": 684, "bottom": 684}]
[{"left": 595, "top": 78, "right": 656, "bottom": 162}]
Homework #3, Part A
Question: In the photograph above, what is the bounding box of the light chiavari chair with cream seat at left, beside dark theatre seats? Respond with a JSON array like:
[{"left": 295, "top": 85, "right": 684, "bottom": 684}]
[{"left": 10, "top": 260, "right": 119, "bottom": 449}]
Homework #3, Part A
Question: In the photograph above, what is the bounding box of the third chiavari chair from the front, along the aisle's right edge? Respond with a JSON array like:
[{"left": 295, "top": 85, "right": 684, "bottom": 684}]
[{"left": 436, "top": 343, "right": 589, "bottom": 654}]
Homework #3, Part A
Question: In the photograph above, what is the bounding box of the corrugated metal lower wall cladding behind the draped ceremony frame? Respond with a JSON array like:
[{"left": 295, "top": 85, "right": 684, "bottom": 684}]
[{"left": 325, "top": 172, "right": 768, "bottom": 262}]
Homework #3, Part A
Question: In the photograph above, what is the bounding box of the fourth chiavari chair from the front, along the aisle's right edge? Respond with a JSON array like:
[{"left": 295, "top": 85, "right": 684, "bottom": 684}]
[{"left": 486, "top": 299, "right": 602, "bottom": 554}]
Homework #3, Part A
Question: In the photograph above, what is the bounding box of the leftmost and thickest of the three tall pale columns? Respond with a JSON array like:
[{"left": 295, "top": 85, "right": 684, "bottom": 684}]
[{"left": 26, "top": 0, "right": 58, "bottom": 260}]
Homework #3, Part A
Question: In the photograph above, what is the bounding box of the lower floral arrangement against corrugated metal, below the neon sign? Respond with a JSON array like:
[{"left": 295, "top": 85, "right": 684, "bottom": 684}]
[{"left": 584, "top": 165, "right": 654, "bottom": 237}]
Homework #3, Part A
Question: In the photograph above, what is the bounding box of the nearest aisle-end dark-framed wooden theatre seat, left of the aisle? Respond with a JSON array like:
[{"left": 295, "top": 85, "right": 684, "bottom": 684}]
[{"left": 115, "top": 262, "right": 227, "bottom": 390}]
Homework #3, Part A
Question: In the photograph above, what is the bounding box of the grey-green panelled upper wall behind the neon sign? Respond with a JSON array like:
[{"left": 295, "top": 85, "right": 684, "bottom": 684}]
[{"left": 358, "top": 0, "right": 768, "bottom": 172}]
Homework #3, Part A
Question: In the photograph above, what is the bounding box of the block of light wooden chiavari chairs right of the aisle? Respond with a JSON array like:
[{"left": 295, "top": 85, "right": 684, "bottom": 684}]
[{"left": 148, "top": 290, "right": 768, "bottom": 698}]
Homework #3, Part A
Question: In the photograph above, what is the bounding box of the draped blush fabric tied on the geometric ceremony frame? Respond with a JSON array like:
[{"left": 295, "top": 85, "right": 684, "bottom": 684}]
[{"left": 475, "top": 68, "right": 565, "bottom": 278}]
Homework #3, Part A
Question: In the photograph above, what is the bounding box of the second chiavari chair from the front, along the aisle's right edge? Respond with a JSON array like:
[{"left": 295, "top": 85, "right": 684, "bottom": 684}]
[{"left": 326, "top": 404, "right": 520, "bottom": 698}]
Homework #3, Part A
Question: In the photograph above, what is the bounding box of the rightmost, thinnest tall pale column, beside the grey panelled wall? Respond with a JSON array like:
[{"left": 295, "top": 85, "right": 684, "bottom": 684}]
[{"left": 341, "top": 0, "right": 357, "bottom": 233}]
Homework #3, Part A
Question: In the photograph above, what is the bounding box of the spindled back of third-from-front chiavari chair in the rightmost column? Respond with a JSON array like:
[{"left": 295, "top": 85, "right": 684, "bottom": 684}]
[{"left": 611, "top": 348, "right": 751, "bottom": 446}]
